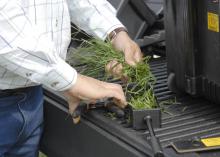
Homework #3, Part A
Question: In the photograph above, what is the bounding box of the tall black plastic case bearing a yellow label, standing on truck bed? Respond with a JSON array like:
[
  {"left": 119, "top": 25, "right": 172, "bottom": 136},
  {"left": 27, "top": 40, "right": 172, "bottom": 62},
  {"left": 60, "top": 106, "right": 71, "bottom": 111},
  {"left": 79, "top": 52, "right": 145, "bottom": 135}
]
[{"left": 165, "top": 0, "right": 220, "bottom": 102}]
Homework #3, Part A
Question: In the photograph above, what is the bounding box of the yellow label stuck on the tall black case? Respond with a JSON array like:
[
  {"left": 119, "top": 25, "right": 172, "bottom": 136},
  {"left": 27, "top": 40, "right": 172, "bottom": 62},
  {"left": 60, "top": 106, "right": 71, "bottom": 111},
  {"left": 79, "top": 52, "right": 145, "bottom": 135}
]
[{"left": 208, "top": 12, "right": 219, "bottom": 32}]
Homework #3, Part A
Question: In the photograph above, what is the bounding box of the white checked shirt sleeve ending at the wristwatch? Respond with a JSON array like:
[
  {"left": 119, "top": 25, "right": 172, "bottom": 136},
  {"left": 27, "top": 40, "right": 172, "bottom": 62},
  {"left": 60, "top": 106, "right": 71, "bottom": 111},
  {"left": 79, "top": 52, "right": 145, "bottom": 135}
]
[{"left": 67, "top": 0, "right": 124, "bottom": 40}]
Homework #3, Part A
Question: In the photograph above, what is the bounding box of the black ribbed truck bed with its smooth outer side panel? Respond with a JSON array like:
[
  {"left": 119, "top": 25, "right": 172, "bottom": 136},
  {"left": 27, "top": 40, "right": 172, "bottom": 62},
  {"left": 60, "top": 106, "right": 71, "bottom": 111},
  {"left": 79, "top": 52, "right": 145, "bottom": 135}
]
[{"left": 41, "top": 59, "right": 220, "bottom": 157}]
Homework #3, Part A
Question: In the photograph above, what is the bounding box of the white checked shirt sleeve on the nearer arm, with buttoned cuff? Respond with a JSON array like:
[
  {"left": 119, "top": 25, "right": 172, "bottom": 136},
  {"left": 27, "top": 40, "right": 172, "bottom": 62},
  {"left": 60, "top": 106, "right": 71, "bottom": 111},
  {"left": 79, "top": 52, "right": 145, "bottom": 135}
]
[{"left": 0, "top": 0, "right": 77, "bottom": 91}]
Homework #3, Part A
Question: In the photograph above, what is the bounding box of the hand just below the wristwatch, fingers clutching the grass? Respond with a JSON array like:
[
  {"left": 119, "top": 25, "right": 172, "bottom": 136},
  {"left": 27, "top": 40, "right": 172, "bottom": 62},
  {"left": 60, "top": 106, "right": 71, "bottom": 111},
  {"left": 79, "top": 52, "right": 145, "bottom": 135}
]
[{"left": 106, "top": 31, "right": 143, "bottom": 78}]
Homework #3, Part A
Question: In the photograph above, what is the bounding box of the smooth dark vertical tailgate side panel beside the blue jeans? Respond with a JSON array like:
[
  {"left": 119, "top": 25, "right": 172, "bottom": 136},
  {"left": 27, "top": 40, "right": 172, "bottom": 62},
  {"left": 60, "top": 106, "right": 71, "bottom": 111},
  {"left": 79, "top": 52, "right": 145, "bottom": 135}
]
[{"left": 41, "top": 100, "right": 150, "bottom": 157}]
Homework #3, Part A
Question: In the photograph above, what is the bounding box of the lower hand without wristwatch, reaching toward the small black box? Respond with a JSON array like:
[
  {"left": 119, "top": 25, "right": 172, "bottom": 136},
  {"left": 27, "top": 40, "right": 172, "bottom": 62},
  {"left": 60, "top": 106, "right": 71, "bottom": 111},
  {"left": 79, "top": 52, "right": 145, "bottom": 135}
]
[{"left": 64, "top": 74, "right": 127, "bottom": 122}]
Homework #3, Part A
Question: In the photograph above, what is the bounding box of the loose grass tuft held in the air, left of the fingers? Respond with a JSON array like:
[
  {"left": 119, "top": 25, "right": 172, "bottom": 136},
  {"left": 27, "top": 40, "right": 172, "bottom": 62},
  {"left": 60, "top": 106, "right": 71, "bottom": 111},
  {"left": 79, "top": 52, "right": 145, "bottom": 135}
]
[{"left": 73, "top": 39, "right": 124, "bottom": 77}]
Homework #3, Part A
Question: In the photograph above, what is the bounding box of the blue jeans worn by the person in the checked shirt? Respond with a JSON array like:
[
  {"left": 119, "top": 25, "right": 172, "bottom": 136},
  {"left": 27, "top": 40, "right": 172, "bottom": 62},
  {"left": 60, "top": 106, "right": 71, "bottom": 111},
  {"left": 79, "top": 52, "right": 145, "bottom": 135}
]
[{"left": 0, "top": 86, "right": 43, "bottom": 157}]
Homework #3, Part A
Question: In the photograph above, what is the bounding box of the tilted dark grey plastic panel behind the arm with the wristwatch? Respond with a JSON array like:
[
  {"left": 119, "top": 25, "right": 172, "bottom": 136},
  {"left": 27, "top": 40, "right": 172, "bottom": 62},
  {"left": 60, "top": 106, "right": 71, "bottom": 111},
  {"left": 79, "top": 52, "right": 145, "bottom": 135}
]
[{"left": 108, "top": 0, "right": 156, "bottom": 39}]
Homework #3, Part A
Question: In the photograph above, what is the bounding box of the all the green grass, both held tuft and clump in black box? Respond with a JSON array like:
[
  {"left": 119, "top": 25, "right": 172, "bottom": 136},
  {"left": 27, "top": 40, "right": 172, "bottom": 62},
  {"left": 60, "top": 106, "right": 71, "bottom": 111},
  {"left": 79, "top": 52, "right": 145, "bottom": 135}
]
[{"left": 72, "top": 38, "right": 157, "bottom": 109}]
